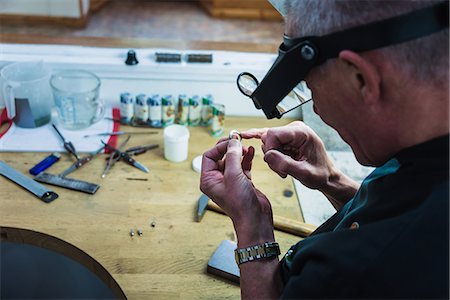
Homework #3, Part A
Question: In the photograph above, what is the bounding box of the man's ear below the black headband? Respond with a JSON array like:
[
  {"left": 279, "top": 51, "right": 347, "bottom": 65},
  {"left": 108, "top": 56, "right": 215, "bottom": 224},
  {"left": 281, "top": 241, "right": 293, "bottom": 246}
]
[{"left": 339, "top": 50, "right": 381, "bottom": 104}]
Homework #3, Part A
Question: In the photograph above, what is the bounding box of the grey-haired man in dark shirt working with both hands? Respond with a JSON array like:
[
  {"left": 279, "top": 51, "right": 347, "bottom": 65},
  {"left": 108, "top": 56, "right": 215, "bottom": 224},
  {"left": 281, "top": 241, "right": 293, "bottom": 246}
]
[{"left": 200, "top": 0, "right": 449, "bottom": 299}]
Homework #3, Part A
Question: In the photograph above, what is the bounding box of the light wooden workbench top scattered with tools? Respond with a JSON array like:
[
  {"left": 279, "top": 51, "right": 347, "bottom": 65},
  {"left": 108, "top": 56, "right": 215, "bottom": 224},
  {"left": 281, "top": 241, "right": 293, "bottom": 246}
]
[{"left": 0, "top": 117, "right": 301, "bottom": 299}]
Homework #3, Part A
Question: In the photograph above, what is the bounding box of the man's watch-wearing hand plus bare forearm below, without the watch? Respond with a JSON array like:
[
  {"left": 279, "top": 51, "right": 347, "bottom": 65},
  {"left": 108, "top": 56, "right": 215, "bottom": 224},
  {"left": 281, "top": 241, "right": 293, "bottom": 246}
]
[{"left": 200, "top": 139, "right": 282, "bottom": 299}]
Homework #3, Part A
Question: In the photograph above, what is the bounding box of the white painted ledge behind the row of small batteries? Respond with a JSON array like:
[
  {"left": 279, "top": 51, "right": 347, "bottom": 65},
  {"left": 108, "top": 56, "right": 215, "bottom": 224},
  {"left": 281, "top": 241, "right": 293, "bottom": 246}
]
[{"left": 0, "top": 44, "right": 300, "bottom": 117}]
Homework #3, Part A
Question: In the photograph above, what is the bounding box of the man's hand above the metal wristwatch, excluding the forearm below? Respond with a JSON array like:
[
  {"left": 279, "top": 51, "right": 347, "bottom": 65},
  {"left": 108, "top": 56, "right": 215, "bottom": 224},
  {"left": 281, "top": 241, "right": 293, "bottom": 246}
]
[{"left": 200, "top": 139, "right": 274, "bottom": 247}]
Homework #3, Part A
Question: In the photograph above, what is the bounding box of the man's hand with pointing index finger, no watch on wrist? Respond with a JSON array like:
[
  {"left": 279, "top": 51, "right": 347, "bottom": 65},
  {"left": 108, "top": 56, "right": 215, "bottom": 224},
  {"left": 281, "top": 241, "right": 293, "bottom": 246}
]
[{"left": 241, "top": 121, "right": 359, "bottom": 209}]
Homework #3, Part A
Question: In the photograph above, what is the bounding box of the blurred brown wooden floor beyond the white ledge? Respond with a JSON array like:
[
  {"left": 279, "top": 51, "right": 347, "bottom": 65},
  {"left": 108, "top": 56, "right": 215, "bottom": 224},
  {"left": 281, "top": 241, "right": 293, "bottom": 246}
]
[{"left": 0, "top": 0, "right": 283, "bottom": 45}]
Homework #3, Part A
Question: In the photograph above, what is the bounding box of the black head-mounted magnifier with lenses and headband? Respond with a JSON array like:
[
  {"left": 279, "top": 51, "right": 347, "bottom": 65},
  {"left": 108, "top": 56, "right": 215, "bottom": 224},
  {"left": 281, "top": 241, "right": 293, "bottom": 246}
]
[{"left": 237, "top": 1, "right": 449, "bottom": 119}]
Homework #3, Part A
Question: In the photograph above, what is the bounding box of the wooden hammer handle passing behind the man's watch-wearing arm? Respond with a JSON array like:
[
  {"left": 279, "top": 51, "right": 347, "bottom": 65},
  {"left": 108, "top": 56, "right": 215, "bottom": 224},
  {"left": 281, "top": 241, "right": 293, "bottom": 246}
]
[{"left": 207, "top": 201, "right": 317, "bottom": 237}]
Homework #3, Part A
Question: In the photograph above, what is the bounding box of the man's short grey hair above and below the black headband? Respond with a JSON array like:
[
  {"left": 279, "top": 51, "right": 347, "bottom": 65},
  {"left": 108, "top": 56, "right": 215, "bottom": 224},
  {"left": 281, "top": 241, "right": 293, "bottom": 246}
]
[{"left": 286, "top": 0, "right": 449, "bottom": 84}]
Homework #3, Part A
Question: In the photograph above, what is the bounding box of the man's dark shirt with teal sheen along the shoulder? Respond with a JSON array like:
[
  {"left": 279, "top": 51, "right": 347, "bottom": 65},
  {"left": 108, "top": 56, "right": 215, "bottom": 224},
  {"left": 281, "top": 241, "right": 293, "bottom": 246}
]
[{"left": 281, "top": 135, "right": 449, "bottom": 299}]
